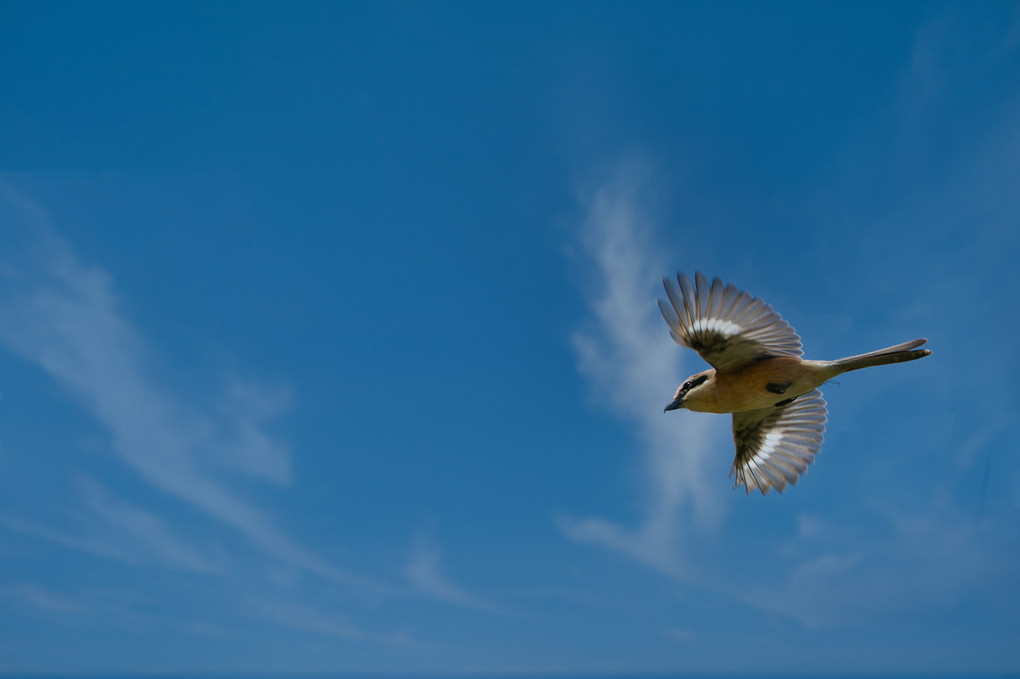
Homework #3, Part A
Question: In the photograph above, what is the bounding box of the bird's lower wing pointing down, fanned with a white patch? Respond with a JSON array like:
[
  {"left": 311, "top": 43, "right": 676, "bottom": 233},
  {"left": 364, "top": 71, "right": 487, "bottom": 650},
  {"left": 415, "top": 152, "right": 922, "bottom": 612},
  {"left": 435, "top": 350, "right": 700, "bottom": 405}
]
[{"left": 729, "top": 389, "right": 826, "bottom": 495}]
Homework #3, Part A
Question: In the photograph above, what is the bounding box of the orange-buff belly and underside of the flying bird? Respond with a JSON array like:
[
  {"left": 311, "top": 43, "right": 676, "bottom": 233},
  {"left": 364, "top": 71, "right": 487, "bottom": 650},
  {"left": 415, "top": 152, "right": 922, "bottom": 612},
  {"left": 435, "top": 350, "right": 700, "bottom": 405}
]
[{"left": 683, "top": 357, "right": 835, "bottom": 413}]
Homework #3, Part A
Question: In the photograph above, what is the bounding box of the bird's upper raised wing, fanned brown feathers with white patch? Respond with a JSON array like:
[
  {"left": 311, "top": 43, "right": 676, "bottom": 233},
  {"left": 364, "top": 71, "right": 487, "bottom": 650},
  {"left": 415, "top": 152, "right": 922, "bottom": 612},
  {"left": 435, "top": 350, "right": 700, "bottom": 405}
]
[{"left": 659, "top": 271, "right": 803, "bottom": 370}]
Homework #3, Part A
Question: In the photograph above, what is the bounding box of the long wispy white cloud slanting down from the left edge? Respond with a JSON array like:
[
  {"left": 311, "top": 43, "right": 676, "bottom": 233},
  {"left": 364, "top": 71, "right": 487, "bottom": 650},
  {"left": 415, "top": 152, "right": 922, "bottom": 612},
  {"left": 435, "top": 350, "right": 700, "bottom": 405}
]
[{"left": 0, "top": 181, "right": 368, "bottom": 584}]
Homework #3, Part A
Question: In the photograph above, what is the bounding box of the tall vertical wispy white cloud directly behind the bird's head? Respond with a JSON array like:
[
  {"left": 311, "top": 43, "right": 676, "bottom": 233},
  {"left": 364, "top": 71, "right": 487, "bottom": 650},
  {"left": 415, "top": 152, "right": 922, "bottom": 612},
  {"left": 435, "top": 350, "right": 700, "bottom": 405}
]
[{"left": 559, "top": 163, "right": 726, "bottom": 576}]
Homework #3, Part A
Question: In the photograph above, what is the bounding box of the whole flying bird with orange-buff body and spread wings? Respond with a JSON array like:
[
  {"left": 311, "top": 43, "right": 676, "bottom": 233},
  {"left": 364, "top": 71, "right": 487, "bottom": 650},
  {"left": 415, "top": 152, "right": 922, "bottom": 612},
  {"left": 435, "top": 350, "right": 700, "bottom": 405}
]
[{"left": 659, "top": 271, "right": 931, "bottom": 495}]
